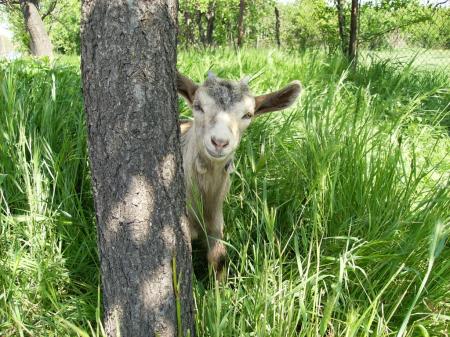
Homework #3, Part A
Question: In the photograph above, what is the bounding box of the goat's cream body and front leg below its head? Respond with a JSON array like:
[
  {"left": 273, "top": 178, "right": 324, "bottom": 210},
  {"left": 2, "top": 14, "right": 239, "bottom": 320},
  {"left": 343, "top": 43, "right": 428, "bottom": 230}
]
[{"left": 181, "top": 124, "right": 230, "bottom": 270}]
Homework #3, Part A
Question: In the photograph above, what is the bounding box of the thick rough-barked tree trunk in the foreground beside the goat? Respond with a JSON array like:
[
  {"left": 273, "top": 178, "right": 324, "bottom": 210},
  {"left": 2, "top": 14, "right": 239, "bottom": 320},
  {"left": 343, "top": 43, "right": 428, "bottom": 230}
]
[{"left": 81, "top": 0, "right": 194, "bottom": 337}]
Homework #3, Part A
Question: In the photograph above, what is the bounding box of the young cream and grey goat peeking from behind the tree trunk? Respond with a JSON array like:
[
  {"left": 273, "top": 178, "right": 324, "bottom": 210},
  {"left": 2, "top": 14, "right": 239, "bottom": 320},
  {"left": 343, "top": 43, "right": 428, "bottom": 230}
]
[{"left": 177, "top": 73, "right": 301, "bottom": 279}]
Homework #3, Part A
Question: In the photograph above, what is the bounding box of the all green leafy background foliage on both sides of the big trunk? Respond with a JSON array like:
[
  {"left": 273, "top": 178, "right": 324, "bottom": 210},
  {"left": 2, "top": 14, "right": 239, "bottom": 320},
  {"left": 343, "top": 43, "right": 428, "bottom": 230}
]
[{"left": 2, "top": 0, "right": 450, "bottom": 54}]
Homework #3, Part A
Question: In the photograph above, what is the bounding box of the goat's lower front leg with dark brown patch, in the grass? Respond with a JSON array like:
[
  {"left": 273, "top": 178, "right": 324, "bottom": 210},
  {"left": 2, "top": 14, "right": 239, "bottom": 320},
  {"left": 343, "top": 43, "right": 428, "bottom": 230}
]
[{"left": 208, "top": 215, "right": 227, "bottom": 281}]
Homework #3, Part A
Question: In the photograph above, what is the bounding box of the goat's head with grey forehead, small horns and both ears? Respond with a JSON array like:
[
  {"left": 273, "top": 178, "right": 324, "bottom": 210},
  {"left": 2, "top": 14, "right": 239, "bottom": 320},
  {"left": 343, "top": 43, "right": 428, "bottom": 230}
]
[{"left": 177, "top": 73, "right": 301, "bottom": 161}]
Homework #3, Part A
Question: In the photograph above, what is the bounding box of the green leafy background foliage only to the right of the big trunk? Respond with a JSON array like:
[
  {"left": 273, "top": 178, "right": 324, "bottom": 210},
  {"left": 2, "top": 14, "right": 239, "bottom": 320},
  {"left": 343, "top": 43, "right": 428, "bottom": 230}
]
[{"left": 179, "top": 0, "right": 450, "bottom": 50}]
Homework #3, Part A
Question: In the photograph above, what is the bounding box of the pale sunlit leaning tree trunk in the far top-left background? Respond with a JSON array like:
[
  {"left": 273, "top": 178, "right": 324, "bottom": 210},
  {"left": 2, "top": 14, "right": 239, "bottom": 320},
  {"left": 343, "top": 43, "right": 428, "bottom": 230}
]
[{"left": 20, "top": 0, "right": 53, "bottom": 57}]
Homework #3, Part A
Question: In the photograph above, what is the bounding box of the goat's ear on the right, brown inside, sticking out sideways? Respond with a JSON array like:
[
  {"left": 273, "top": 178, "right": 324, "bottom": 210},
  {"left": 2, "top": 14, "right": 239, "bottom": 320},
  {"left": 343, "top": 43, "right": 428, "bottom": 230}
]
[{"left": 255, "top": 81, "right": 302, "bottom": 116}]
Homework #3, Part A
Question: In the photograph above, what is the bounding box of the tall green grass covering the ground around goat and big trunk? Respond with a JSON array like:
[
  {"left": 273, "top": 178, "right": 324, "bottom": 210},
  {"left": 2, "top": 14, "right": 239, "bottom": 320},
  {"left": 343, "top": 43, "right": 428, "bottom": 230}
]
[{"left": 0, "top": 49, "right": 450, "bottom": 337}]
